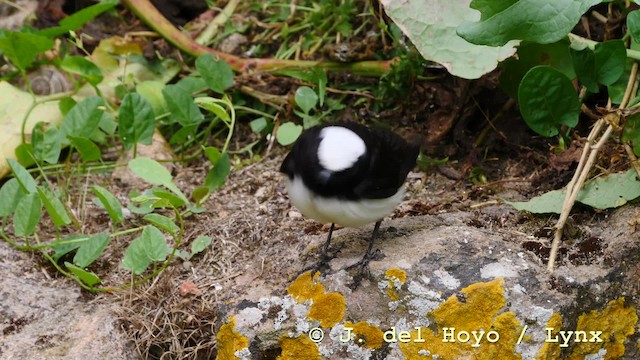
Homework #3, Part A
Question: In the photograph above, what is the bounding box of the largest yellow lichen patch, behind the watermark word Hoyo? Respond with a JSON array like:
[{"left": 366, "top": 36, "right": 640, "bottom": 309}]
[{"left": 399, "top": 279, "right": 521, "bottom": 360}]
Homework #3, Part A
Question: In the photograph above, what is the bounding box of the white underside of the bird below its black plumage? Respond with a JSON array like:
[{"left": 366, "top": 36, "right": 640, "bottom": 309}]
[{"left": 286, "top": 176, "right": 404, "bottom": 227}]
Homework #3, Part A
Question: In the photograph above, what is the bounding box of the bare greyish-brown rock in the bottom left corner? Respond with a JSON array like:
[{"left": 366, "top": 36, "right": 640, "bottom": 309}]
[{"left": 0, "top": 241, "right": 137, "bottom": 360}]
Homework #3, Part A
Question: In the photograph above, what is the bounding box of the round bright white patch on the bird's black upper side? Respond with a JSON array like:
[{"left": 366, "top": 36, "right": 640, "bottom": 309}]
[{"left": 318, "top": 126, "right": 367, "bottom": 171}]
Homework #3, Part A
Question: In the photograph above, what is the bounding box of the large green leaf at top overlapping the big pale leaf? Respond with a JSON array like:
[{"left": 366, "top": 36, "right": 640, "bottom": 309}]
[{"left": 458, "top": 0, "right": 601, "bottom": 46}]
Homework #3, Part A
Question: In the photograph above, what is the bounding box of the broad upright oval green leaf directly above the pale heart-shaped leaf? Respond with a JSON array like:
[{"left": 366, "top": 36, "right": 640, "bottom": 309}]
[{"left": 118, "top": 93, "right": 156, "bottom": 149}]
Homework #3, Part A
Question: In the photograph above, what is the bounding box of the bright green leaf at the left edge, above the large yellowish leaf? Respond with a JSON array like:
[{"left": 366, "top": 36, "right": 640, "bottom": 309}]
[{"left": 0, "top": 30, "right": 53, "bottom": 71}]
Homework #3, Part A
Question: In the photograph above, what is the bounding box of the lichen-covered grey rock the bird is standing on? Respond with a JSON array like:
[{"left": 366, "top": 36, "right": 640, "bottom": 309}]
[{"left": 218, "top": 213, "right": 640, "bottom": 360}]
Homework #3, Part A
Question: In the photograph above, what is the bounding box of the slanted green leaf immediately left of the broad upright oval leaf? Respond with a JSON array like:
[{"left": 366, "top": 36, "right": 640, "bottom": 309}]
[{"left": 60, "top": 96, "right": 104, "bottom": 145}]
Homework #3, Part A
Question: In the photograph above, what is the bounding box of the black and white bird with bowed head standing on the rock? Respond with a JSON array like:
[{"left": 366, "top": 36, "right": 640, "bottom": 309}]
[{"left": 280, "top": 123, "right": 419, "bottom": 274}]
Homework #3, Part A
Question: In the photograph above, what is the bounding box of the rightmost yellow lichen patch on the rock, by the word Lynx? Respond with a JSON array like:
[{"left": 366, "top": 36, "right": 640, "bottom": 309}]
[{"left": 569, "top": 298, "right": 638, "bottom": 360}]
